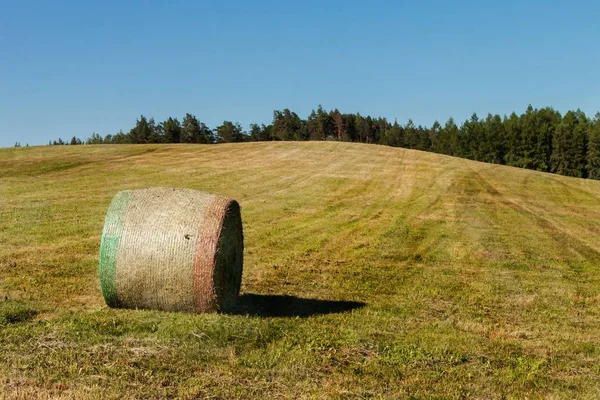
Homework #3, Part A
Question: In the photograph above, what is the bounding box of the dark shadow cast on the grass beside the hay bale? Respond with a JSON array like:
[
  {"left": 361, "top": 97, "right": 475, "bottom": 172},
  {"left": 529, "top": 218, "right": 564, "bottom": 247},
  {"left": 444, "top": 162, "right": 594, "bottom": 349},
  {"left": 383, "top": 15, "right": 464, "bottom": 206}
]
[{"left": 224, "top": 293, "right": 366, "bottom": 317}]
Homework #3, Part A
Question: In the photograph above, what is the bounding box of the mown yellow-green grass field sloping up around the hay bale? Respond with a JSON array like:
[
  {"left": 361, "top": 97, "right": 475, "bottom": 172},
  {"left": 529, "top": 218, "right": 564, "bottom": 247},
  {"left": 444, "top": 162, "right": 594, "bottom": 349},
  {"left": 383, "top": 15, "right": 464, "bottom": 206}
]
[{"left": 0, "top": 142, "right": 600, "bottom": 399}]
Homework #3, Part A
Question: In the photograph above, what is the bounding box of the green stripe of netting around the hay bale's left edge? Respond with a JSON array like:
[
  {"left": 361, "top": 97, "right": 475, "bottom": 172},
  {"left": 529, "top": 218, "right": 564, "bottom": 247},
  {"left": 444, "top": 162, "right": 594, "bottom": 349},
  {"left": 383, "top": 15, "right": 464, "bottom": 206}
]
[{"left": 99, "top": 191, "right": 131, "bottom": 307}]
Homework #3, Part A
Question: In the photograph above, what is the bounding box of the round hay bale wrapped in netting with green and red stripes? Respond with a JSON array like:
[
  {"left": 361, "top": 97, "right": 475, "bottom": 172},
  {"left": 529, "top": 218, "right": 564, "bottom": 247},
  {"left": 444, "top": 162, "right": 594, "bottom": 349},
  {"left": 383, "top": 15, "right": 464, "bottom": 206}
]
[{"left": 99, "top": 188, "right": 244, "bottom": 312}]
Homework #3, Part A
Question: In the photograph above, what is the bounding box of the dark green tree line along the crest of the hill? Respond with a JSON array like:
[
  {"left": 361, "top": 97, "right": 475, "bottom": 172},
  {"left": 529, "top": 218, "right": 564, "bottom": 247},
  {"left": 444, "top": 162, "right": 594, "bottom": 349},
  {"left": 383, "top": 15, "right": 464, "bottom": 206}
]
[{"left": 51, "top": 105, "right": 600, "bottom": 179}]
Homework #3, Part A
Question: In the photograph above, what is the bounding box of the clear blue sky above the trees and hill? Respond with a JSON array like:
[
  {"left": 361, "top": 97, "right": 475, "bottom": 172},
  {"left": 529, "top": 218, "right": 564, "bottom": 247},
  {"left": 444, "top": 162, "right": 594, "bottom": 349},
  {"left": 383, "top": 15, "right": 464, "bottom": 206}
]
[{"left": 0, "top": 0, "right": 600, "bottom": 146}]
